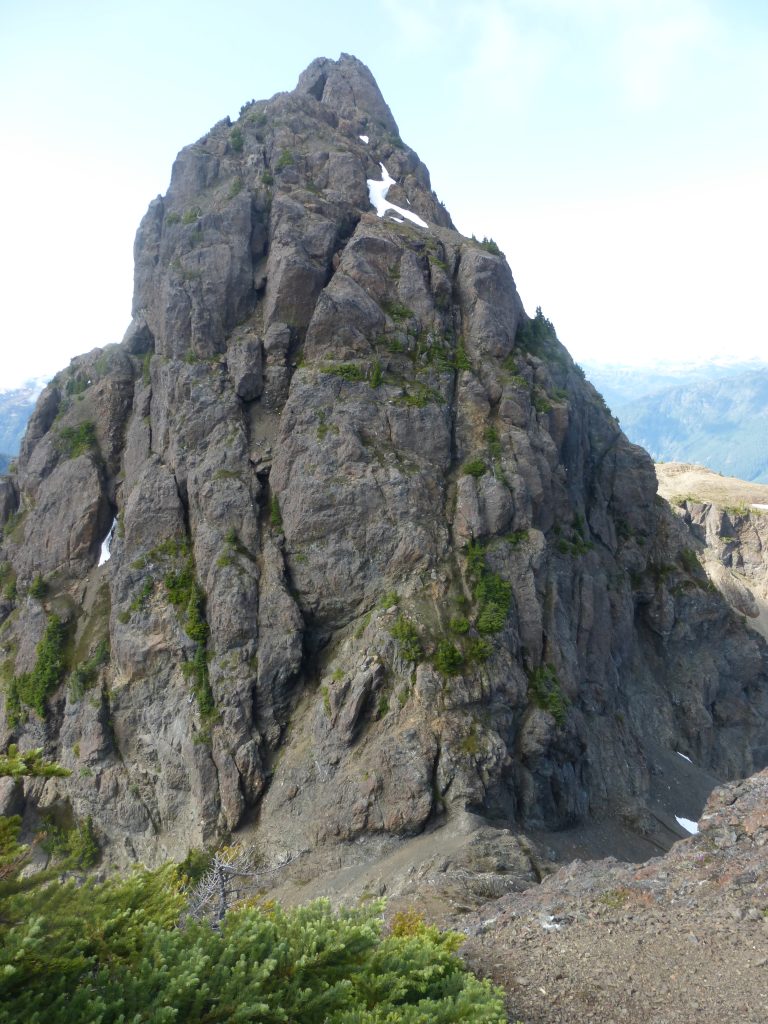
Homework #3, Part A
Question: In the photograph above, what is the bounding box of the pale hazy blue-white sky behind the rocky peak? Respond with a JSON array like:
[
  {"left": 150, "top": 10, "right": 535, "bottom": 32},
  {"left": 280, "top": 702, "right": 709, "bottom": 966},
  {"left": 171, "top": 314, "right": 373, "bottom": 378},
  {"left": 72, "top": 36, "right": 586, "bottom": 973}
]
[{"left": 0, "top": 0, "right": 768, "bottom": 387}]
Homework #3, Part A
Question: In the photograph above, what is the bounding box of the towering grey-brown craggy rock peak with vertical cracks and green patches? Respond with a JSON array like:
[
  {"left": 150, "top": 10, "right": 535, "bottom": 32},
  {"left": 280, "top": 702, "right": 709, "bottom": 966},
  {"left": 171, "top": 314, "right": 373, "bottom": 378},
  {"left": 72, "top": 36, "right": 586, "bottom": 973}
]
[{"left": 0, "top": 55, "right": 768, "bottom": 863}]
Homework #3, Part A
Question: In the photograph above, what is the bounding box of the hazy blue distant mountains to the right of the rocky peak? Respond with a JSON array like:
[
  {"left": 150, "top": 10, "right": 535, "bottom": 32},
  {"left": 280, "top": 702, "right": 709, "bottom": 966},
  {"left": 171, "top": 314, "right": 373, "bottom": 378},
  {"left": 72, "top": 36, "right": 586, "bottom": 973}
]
[{"left": 584, "top": 360, "right": 768, "bottom": 483}]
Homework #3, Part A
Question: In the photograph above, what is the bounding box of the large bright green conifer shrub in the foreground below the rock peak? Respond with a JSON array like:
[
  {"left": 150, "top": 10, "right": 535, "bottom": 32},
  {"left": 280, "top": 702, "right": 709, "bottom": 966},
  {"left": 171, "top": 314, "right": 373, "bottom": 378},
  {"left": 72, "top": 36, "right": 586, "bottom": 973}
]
[{"left": 0, "top": 865, "right": 507, "bottom": 1024}]
